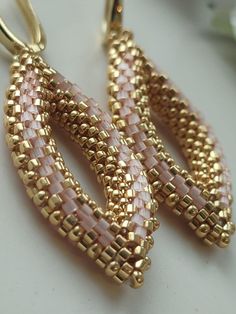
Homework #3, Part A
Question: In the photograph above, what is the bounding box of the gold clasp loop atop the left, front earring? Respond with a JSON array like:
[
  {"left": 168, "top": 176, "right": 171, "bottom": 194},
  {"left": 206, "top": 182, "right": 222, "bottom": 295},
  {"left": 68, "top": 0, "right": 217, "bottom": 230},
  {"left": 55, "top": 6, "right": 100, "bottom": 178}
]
[{"left": 0, "top": 0, "right": 46, "bottom": 54}]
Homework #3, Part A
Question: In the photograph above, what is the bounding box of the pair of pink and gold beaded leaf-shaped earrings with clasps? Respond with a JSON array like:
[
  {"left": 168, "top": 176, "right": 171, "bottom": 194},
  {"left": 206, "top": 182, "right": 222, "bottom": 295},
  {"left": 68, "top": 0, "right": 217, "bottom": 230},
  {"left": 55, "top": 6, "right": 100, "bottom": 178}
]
[{"left": 0, "top": 0, "right": 235, "bottom": 288}]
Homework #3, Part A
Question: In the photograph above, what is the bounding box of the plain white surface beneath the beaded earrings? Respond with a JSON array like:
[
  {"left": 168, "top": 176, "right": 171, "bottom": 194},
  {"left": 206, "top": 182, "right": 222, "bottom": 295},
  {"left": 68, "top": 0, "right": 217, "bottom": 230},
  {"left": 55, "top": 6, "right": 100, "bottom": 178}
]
[{"left": 0, "top": 0, "right": 236, "bottom": 314}]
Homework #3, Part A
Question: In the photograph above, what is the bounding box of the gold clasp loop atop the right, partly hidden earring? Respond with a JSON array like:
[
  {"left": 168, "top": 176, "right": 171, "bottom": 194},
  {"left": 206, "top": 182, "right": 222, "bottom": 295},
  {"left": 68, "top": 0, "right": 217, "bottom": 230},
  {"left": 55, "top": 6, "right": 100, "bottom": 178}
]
[{"left": 103, "top": 0, "right": 123, "bottom": 43}]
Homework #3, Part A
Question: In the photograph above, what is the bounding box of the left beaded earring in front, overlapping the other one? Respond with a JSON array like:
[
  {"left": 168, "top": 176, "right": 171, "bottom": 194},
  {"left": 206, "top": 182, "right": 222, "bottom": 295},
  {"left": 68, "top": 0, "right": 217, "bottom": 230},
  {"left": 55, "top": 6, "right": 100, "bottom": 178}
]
[{"left": 0, "top": 0, "right": 158, "bottom": 288}]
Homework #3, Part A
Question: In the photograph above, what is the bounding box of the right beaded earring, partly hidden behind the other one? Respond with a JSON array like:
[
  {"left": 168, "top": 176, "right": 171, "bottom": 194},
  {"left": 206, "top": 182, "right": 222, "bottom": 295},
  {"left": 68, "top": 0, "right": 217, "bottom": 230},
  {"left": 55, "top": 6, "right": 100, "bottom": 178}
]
[{"left": 104, "top": 0, "right": 235, "bottom": 247}]
